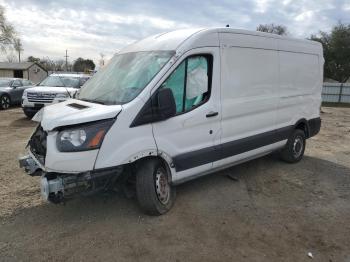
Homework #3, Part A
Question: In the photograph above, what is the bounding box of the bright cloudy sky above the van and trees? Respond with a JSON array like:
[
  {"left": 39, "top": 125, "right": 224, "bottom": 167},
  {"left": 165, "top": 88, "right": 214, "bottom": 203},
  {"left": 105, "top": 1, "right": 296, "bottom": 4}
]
[{"left": 0, "top": 0, "right": 350, "bottom": 63}]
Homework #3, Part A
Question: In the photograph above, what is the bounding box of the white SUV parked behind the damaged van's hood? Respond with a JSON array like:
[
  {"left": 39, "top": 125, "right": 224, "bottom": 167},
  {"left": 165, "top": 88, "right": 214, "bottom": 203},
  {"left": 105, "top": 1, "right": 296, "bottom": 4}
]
[{"left": 22, "top": 74, "right": 90, "bottom": 118}]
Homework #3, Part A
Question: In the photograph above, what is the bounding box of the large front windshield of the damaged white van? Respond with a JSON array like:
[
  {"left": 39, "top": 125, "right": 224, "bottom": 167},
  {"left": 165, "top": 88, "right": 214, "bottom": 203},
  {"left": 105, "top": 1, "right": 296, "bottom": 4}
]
[{"left": 79, "top": 51, "right": 174, "bottom": 105}]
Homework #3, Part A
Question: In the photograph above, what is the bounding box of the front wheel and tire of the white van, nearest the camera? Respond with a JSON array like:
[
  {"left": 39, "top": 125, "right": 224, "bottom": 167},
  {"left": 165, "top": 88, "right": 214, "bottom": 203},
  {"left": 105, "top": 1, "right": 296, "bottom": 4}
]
[{"left": 136, "top": 159, "right": 176, "bottom": 216}]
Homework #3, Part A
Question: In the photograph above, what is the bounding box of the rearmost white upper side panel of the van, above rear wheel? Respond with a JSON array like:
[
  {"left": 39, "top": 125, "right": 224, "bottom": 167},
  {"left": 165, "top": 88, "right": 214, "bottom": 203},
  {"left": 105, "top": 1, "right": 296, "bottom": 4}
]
[{"left": 276, "top": 40, "right": 323, "bottom": 130}]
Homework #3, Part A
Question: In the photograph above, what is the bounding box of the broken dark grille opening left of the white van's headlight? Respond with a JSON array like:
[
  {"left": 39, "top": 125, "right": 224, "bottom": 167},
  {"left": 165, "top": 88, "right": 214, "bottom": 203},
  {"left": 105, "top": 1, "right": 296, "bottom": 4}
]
[{"left": 28, "top": 125, "right": 47, "bottom": 164}]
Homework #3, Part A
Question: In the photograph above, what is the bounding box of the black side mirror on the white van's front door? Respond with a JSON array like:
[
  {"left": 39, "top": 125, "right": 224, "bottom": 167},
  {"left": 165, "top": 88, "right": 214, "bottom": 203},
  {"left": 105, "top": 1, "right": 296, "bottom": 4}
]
[{"left": 157, "top": 88, "right": 176, "bottom": 120}]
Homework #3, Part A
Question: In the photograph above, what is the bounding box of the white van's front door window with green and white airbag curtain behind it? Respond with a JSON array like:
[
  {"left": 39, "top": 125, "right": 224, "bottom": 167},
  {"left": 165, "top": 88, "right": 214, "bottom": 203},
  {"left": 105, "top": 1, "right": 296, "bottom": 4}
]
[{"left": 161, "top": 55, "right": 212, "bottom": 113}]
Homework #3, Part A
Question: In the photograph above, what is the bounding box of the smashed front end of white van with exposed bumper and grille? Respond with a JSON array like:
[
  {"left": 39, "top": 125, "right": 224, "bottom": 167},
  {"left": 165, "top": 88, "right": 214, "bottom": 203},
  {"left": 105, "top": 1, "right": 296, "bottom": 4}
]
[{"left": 19, "top": 125, "right": 123, "bottom": 203}]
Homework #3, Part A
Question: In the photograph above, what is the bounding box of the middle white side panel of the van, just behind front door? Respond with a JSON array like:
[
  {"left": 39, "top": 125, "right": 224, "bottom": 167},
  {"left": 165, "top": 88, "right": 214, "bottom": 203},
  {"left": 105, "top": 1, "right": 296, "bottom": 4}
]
[{"left": 215, "top": 33, "right": 279, "bottom": 166}]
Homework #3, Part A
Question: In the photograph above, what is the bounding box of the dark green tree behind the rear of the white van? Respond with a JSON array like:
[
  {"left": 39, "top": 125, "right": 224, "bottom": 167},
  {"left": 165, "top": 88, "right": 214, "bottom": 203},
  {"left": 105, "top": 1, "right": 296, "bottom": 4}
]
[{"left": 311, "top": 23, "right": 350, "bottom": 83}]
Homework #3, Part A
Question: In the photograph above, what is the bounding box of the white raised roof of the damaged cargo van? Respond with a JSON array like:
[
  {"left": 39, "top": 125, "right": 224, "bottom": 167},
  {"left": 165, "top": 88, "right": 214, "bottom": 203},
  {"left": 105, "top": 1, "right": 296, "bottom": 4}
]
[{"left": 119, "top": 27, "right": 321, "bottom": 53}]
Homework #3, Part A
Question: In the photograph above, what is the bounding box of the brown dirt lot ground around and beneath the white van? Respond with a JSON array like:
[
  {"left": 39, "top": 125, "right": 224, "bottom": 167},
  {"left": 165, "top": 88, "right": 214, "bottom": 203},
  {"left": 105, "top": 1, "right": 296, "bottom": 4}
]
[{"left": 0, "top": 108, "right": 350, "bottom": 262}]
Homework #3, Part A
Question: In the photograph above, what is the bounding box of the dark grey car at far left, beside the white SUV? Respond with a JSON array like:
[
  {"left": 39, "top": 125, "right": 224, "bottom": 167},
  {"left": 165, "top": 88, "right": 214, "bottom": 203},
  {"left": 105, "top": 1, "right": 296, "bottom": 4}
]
[{"left": 0, "top": 78, "right": 34, "bottom": 110}]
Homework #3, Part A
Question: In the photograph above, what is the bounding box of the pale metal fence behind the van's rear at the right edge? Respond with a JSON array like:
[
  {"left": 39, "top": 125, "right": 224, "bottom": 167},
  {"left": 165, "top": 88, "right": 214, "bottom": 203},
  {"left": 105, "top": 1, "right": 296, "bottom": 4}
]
[{"left": 322, "top": 83, "right": 350, "bottom": 104}]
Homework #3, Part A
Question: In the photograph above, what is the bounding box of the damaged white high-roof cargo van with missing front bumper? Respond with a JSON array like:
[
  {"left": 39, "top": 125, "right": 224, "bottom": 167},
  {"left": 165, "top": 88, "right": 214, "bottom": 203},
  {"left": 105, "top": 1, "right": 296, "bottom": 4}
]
[{"left": 19, "top": 28, "right": 324, "bottom": 215}]
